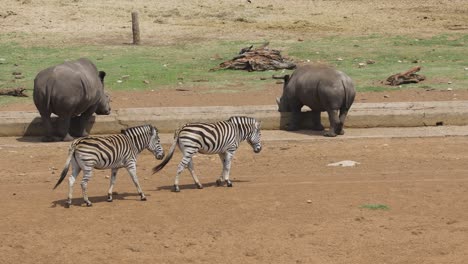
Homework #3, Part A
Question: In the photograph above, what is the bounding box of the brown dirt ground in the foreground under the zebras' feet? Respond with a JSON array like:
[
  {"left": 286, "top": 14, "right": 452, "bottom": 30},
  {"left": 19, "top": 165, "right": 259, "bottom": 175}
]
[{"left": 0, "top": 137, "right": 468, "bottom": 263}]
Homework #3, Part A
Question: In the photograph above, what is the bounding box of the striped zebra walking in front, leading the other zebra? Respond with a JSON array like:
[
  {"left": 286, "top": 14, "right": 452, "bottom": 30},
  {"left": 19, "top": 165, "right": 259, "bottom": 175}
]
[{"left": 153, "top": 116, "right": 262, "bottom": 192}]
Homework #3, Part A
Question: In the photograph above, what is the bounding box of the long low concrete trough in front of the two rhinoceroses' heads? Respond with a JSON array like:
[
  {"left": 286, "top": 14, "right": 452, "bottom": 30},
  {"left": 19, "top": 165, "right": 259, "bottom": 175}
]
[{"left": 0, "top": 101, "right": 468, "bottom": 136}]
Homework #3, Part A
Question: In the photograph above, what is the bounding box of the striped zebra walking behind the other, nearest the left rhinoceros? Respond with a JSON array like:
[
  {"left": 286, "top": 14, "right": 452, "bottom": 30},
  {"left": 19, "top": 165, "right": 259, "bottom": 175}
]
[{"left": 54, "top": 125, "right": 164, "bottom": 207}]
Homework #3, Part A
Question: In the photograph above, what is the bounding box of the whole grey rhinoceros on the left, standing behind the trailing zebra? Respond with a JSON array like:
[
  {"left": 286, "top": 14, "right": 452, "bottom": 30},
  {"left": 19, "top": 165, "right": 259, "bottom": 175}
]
[{"left": 33, "top": 58, "right": 110, "bottom": 141}]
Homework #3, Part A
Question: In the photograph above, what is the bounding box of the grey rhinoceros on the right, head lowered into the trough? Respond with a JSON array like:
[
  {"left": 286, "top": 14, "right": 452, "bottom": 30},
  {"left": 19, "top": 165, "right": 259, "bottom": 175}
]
[{"left": 276, "top": 64, "right": 356, "bottom": 137}]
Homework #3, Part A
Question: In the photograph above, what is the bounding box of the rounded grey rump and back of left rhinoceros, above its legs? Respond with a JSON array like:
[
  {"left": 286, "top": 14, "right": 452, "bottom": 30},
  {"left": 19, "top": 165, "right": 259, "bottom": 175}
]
[{"left": 34, "top": 59, "right": 104, "bottom": 116}]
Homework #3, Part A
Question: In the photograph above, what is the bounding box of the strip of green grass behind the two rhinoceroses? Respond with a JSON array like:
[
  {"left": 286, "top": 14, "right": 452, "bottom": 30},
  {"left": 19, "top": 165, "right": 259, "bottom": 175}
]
[{"left": 0, "top": 34, "right": 468, "bottom": 104}]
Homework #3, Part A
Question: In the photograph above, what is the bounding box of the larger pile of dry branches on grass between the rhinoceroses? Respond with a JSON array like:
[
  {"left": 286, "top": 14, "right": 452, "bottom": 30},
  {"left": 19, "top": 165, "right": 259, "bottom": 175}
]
[{"left": 211, "top": 46, "right": 296, "bottom": 72}]
